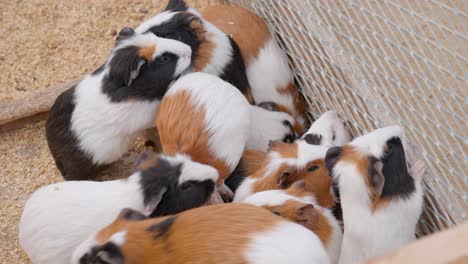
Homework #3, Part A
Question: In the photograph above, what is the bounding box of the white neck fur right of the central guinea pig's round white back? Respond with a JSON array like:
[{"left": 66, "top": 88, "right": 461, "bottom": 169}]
[{"left": 247, "top": 105, "right": 294, "bottom": 152}]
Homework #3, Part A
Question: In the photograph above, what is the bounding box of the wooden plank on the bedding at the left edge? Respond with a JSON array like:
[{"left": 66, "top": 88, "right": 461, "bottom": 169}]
[{"left": 0, "top": 79, "right": 79, "bottom": 126}]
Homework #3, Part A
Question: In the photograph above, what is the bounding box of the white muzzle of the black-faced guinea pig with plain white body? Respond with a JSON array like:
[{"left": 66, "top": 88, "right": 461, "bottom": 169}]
[{"left": 166, "top": 154, "right": 219, "bottom": 184}]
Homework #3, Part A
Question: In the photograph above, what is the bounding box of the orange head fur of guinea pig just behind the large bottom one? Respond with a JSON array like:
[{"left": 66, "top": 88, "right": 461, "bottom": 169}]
[{"left": 263, "top": 199, "right": 333, "bottom": 245}]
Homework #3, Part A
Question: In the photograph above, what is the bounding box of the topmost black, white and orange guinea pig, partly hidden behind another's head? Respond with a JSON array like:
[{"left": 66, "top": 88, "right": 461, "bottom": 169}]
[{"left": 136, "top": 0, "right": 254, "bottom": 103}]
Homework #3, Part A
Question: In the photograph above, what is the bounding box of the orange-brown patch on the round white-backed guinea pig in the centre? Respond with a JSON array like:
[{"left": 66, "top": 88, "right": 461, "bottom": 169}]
[{"left": 156, "top": 91, "right": 231, "bottom": 184}]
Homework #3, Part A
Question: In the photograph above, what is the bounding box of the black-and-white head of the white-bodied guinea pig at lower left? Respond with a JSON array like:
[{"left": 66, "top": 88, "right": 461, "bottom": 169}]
[{"left": 136, "top": 152, "right": 218, "bottom": 217}]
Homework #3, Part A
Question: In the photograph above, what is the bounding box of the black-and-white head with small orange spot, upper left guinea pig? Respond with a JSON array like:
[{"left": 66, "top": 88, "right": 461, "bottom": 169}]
[{"left": 101, "top": 27, "right": 191, "bottom": 102}]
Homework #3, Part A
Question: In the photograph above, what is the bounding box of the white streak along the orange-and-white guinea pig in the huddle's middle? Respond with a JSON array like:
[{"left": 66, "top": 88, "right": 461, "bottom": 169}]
[{"left": 233, "top": 141, "right": 328, "bottom": 202}]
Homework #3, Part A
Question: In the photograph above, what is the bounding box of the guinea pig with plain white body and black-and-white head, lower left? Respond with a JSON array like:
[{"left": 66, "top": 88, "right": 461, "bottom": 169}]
[{"left": 19, "top": 154, "right": 218, "bottom": 264}]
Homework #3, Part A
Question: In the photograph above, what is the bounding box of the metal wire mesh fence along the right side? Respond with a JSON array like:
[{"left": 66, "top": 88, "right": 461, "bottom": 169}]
[{"left": 226, "top": 0, "right": 468, "bottom": 235}]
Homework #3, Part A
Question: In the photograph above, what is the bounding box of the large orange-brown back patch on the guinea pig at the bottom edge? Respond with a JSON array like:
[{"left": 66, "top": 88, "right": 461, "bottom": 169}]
[{"left": 92, "top": 203, "right": 282, "bottom": 264}]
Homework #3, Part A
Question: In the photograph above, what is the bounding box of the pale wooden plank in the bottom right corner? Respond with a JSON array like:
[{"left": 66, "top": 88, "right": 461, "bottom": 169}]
[{"left": 367, "top": 222, "right": 468, "bottom": 264}]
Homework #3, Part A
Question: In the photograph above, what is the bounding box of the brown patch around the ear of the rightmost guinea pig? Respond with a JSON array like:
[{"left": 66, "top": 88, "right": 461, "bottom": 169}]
[{"left": 339, "top": 146, "right": 391, "bottom": 212}]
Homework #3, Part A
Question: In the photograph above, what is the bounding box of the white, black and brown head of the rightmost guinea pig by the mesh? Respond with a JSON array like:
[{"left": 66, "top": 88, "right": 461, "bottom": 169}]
[{"left": 325, "top": 126, "right": 420, "bottom": 210}]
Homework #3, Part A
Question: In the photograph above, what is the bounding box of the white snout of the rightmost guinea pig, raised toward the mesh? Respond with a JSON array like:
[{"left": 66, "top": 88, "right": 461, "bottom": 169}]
[{"left": 350, "top": 126, "right": 404, "bottom": 158}]
